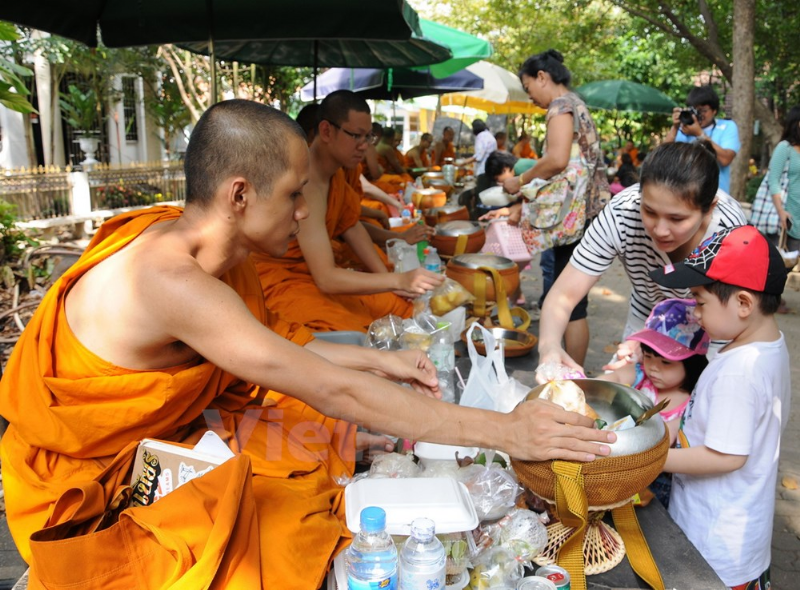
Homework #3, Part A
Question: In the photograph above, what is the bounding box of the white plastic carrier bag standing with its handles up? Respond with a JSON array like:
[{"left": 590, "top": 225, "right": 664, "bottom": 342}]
[{"left": 460, "top": 322, "right": 530, "bottom": 413}]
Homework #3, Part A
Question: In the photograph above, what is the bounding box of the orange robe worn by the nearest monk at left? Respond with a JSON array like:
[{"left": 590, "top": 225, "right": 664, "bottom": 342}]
[{"left": 0, "top": 207, "right": 355, "bottom": 590}]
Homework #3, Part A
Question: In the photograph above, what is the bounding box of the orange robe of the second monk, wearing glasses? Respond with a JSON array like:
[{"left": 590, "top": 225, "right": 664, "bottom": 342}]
[{"left": 252, "top": 169, "right": 412, "bottom": 332}]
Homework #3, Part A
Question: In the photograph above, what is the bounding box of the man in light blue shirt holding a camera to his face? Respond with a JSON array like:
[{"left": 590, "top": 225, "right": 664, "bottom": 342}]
[{"left": 664, "top": 86, "right": 740, "bottom": 193}]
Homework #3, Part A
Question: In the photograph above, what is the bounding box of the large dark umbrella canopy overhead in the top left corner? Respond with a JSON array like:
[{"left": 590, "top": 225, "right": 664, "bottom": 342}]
[{"left": 0, "top": 0, "right": 422, "bottom": 47}]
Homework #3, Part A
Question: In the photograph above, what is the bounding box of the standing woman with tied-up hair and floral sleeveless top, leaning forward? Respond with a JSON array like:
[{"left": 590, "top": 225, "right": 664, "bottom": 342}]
[{"left": 484, "top": 49, "right": 610, "bottom": 362}]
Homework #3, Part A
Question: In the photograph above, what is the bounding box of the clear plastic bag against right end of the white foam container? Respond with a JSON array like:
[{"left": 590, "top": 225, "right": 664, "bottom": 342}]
[{"left": 458, "top": 463, "right": 522, "bottom": 521}]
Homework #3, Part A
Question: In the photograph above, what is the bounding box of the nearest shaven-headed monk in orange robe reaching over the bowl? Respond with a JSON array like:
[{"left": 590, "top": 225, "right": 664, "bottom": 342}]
[{"left": 0, "top": 100, "right": 614, "bottom": 590}]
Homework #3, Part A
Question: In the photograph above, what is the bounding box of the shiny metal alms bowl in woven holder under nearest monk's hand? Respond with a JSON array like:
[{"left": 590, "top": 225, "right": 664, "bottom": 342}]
[{"left": 525, "top": 379, "right": 666, "bottom": 457}]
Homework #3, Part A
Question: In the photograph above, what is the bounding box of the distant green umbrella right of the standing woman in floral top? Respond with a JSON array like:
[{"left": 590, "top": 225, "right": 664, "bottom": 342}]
[{"left": 575, "top": 80, "right": 678, "bottom": 113}]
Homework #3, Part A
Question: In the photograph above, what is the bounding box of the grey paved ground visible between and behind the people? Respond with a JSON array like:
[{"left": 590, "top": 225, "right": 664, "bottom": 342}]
[{"left": 0, "top": 262, "right": 800, "bottom": 590}]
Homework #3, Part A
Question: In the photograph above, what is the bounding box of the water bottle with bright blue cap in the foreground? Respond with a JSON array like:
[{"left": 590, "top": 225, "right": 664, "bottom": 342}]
[{"left": 345, "top": 506, "right": 397, "bottom": 590}]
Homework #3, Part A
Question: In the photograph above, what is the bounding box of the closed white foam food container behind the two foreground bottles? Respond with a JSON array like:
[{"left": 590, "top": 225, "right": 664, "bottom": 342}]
[{"left": 344, "top": 477, "right": 478, "bottom": 536}]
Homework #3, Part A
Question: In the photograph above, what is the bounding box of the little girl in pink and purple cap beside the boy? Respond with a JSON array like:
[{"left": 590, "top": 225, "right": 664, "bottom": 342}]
[{"left": 599, "top": 299, "right": 708, "bottom": 446}]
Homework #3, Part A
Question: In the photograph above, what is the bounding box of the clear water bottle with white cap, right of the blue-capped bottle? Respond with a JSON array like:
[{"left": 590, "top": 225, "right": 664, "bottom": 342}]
[{"left": 400, "top": 518, "right": 446, "bottom": 590}]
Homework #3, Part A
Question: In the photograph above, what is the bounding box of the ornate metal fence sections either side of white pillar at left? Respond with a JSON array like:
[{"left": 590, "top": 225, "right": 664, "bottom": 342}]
[{"left": 0, "top": 162, "right": 186, "bottom": 221}]
